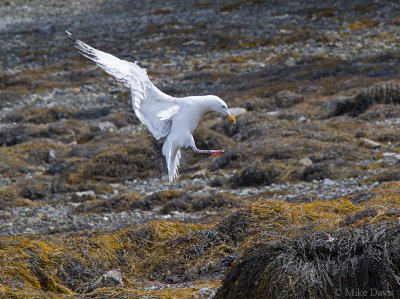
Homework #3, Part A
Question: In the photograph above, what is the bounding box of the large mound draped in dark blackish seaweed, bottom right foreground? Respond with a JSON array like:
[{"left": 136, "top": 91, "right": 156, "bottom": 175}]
[{"left": 215, "top": 223, "right": 400, "bottom": 299}]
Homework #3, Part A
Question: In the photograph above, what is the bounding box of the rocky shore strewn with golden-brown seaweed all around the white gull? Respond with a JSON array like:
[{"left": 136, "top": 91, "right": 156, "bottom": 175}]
[{"left": 0, "top": 0, "right": 400, "bottom": 298}]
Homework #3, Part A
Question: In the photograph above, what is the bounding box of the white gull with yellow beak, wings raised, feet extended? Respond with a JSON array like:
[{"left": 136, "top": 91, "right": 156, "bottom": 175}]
[{"left": 65, "top": 30, "right": 236, "bottom": 182}]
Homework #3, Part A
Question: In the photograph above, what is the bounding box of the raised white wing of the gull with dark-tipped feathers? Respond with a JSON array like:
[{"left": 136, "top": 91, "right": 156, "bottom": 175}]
[{"left": 66, "top": 31, "right": 179, "bottom": 139}]
